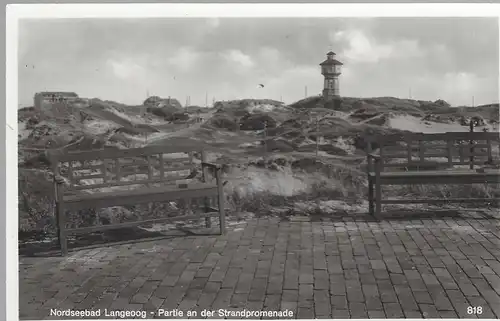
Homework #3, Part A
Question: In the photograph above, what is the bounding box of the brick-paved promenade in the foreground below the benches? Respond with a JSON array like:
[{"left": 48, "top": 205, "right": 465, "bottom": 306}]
[{"left": 19, "top": 212, "right": 500, "bottom": 319}]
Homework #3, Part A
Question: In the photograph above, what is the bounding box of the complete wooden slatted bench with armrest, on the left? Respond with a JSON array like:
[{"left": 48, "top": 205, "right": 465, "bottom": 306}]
[{"left": 48, "top": 146, "right": 225, "bottom": 256}]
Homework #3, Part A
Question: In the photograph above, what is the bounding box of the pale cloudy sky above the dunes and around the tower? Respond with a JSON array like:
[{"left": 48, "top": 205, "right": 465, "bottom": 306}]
[{"left": 18, "top": 18, "right": 499, "bottom": 106}]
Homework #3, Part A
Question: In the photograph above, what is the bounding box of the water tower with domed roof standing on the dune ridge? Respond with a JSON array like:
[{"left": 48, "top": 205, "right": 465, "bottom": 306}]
[{"left": 319, "top": 51, "right": 343, "bottom": 109}]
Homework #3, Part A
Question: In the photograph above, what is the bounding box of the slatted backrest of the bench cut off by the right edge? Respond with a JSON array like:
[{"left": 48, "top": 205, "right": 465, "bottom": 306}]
[{"left": 367, "top": 132, "right": 500, "bottom": 170}]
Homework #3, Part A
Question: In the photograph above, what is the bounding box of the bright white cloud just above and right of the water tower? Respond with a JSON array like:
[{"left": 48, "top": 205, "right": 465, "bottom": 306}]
[{"left": 330, "top": 29, "right": 424, "bottom": 63}]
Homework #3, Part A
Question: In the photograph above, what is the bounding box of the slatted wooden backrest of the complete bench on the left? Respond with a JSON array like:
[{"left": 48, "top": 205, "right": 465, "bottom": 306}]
[{"left": 49, "top": 146, "right": 205, "bottom": 191}]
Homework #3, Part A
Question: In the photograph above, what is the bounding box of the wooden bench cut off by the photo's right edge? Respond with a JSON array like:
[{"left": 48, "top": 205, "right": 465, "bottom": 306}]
[{"left": 366, "top": 132, "right": 500, "bottom": 216}]
